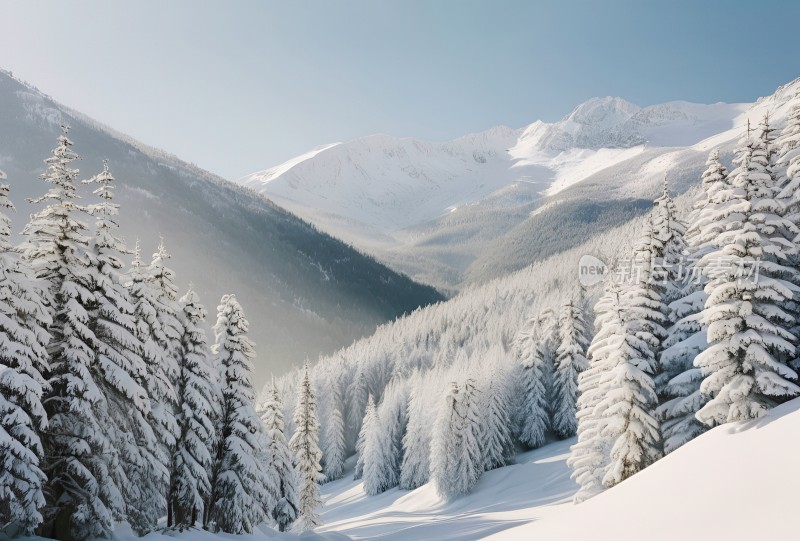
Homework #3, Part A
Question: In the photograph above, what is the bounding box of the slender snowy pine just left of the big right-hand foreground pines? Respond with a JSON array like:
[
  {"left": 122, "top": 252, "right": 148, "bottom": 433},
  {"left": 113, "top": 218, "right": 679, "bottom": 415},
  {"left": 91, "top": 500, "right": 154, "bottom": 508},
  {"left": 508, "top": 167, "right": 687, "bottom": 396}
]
[{"left": 553, "top": 299, "right": 588, "bottom": 438}]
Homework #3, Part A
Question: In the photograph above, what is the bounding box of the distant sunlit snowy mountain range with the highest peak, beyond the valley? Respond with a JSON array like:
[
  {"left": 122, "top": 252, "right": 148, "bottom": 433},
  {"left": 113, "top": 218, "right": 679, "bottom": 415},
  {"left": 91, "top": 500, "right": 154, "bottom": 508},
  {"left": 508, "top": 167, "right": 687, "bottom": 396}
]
[{"left": 239, "top": 81, "right": 798, "bottom": 289}]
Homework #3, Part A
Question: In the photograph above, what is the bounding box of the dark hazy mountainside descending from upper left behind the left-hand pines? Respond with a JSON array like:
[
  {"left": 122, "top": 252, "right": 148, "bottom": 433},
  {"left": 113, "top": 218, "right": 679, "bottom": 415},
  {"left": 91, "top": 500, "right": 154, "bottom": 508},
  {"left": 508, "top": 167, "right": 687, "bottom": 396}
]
[{"left": 0, "top": 68, "right": 441, "bottom": 385}]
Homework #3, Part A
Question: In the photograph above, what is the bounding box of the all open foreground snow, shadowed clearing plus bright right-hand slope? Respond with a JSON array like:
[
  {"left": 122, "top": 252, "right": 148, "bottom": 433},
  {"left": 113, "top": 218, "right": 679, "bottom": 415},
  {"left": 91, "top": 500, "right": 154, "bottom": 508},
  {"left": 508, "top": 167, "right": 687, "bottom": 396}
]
[{"left": 319, "top": 399, "right": 800, "bottom": 541}]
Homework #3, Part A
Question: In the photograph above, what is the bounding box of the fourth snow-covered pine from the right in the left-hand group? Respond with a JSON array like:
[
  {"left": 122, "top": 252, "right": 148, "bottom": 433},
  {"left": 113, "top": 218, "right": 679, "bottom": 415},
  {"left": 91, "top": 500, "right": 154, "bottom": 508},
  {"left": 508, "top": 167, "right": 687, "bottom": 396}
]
[{"left": 167, "top": 286, "right": 219, "bottom": 530}]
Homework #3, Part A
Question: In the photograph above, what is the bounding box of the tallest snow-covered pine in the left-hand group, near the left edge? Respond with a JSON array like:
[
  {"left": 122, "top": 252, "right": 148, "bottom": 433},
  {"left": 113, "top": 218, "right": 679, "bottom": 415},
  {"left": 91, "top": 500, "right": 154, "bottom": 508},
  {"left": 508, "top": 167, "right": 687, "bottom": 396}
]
[{"left": 24, "top": 126, "right": 125, "bottom": 541}]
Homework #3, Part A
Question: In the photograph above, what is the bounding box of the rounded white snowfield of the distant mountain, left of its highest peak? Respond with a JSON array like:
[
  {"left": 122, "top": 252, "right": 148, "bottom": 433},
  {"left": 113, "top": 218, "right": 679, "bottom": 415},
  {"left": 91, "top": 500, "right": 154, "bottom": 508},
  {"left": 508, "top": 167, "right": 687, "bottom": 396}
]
[{"left": 240, "top": 126, "right": 524, "bottom": 233}]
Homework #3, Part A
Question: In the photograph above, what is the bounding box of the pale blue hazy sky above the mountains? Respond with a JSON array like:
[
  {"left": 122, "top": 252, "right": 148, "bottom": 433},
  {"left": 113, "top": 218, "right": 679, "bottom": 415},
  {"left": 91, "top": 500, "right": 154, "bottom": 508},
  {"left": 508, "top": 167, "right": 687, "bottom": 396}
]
[{"left": 0, "top": 0, "right": 800, "bottom": 179}]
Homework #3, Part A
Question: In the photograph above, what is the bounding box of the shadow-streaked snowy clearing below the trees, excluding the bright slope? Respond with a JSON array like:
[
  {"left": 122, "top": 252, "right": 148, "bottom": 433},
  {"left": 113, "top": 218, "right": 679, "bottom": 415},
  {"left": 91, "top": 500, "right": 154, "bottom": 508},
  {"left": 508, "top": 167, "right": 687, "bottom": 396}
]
[{"left": 319, "top": 439, "right": 578, "bottom": 541}]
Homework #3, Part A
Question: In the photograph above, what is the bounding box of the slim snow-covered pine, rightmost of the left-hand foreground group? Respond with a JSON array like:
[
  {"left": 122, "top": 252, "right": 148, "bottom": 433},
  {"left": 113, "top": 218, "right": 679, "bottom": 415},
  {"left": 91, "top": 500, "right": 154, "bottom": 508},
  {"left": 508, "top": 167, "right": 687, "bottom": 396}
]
[{"left": 289, "top": 362, "right": 324, "bottom": 532}]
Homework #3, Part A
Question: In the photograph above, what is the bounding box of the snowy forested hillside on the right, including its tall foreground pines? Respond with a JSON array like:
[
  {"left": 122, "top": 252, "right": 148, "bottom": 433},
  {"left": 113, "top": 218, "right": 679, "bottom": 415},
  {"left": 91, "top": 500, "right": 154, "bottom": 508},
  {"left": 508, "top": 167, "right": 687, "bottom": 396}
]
[{"left": 276, "top": 85, "right": 800, "bottom": 510}]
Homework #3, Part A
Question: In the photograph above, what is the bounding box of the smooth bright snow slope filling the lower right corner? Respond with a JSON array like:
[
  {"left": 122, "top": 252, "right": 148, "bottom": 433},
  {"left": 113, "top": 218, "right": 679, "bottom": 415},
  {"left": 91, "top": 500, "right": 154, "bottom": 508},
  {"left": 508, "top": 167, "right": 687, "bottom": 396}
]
[{"left": 489, "top": 399, "right": 800, "bottom": 541}]
